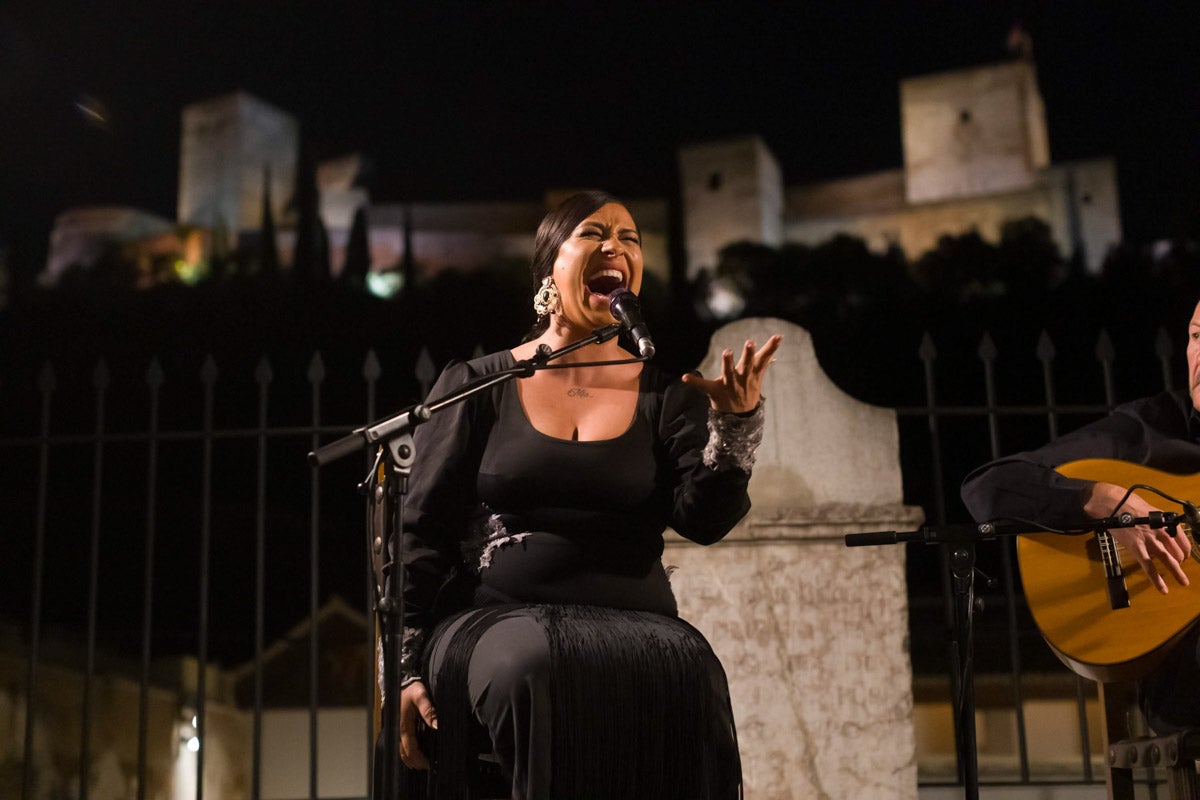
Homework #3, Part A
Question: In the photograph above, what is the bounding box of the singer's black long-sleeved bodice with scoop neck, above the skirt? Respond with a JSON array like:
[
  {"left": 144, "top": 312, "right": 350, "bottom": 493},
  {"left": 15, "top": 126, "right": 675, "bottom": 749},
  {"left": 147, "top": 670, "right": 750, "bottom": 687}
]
[{"left": 402, "top": 350, "right": 750, "bottom": 630}]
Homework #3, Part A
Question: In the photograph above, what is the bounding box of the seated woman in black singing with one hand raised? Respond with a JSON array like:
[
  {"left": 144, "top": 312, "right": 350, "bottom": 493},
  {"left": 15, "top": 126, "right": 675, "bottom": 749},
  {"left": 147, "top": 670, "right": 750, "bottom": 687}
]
[{"left": 400, "top": 192, "right": 780, "bottom": 800}]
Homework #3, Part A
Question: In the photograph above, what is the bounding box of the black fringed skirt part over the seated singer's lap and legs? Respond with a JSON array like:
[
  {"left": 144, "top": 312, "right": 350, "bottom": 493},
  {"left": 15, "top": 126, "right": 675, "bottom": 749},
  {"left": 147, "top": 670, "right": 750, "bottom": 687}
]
[{"left": 412, "top": 604, "right": 742, "bottom": 800}]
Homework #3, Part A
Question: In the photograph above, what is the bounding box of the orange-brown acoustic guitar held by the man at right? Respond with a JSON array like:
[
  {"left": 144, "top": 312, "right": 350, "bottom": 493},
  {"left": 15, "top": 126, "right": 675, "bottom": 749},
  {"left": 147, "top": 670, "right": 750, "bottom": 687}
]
[{"left": 1016, "top": 458, "right": 1200, "bottom": 682}]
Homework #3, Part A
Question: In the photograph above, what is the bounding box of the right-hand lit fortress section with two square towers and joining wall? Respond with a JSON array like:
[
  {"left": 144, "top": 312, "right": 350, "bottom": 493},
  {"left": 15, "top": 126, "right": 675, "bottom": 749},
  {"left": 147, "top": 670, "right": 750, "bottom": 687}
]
[{"left": 679, "top": 59, "right": 1121, "bottom": 277}]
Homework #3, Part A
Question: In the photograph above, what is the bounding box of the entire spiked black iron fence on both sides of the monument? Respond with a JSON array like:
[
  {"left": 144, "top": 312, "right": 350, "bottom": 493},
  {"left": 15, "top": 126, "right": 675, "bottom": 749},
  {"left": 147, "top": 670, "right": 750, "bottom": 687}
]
[{"left": 0, "top": 321, "right": 1177, "bottom": 799}]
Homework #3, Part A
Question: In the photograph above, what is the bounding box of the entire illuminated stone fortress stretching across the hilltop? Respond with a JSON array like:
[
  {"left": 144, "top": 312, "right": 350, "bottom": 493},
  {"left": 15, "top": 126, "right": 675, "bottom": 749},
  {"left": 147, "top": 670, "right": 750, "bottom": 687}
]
[{"left": 39, "top": 58, "right": 1121, "bottom": 287}]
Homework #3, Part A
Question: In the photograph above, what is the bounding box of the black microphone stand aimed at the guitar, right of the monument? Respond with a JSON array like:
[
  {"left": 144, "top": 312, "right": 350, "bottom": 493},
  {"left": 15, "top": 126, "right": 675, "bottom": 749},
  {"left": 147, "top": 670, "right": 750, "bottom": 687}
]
[{"left": 845, "top": 511, "right": 1183, "bottom": 800}]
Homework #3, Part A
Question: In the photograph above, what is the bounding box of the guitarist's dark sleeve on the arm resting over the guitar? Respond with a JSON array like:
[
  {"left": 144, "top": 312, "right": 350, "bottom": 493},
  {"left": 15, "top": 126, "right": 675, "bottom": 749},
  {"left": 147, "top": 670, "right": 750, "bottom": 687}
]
[{"left": 961, "top": 393, "right": 1200, "bottom": 528}]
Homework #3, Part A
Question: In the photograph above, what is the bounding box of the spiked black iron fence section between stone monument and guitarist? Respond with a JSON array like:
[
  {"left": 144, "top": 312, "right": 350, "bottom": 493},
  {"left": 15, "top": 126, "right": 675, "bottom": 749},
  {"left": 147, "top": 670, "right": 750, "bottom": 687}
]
[{"left": 896, "top": 329, "right": 1182, "bottom": 796}]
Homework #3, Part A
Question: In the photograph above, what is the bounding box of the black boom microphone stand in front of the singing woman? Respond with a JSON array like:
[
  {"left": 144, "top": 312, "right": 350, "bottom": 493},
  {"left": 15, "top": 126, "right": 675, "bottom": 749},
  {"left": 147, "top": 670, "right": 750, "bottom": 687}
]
[{"left": 308, "top": 323, "right": 648, "bottom": 800}]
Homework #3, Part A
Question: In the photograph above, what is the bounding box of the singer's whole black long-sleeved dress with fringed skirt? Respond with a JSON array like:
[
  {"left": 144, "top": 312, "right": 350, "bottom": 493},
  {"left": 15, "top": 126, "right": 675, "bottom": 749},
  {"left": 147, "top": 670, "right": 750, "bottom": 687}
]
[{"left": 402, "top": 351, "right": 749, "bottom": 800}]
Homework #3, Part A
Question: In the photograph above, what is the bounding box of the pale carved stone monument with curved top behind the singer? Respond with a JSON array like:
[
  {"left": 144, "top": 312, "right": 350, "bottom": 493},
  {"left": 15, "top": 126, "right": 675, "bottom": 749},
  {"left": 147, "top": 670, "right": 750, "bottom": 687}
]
[{"left": 664, "top": 319, "right": 924, "bottom": 800}]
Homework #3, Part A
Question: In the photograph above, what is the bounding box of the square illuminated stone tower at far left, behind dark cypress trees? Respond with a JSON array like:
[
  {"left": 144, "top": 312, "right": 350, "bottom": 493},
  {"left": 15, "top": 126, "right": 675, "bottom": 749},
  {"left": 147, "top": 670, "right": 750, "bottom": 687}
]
[{"left": 178, "top": 92, "right": 300, "bottom": 243}]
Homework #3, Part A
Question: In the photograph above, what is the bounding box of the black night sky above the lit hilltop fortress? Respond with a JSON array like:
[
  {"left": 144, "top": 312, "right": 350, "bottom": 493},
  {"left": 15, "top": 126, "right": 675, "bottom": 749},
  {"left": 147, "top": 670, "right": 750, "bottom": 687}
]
[{"left": 0, "top": 0, "right": 1200, "bottom": 278}]
